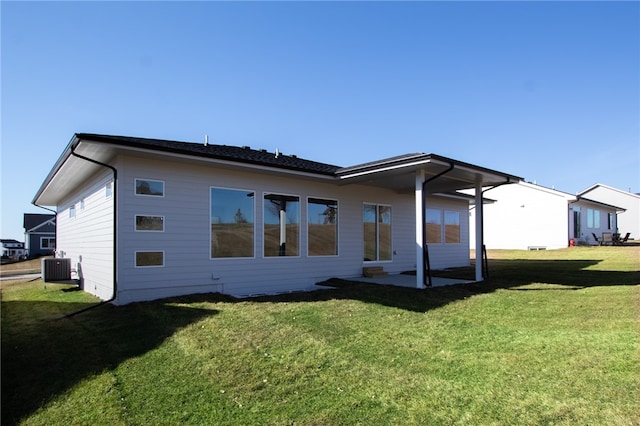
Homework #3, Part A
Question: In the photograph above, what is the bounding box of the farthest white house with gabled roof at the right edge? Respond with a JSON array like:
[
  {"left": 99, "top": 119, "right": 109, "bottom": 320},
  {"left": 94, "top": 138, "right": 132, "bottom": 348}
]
[{"left": 578, "top": 183, "right": 640, "bottom": 240}]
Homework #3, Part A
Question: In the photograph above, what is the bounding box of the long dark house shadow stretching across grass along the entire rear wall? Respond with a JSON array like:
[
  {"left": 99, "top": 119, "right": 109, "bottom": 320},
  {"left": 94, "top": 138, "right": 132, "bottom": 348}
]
[{"left": 2, "top": 260, "right": 640, "bottom": 425}]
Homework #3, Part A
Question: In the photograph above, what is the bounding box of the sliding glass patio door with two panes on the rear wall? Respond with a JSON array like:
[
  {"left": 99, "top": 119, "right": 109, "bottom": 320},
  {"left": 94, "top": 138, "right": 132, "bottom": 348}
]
[{"left": 362, "top": 204, "right": 392, "bottom": 262}]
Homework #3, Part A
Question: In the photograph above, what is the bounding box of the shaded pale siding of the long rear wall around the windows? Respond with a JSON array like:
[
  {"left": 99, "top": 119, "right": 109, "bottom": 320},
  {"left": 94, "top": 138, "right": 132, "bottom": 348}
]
[{"left": 111, "top": 157, "right": 469, "bottom": 304}]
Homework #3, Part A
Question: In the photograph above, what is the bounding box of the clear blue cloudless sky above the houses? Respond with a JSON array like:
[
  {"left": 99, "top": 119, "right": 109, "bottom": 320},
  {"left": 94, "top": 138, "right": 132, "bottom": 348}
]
[{"left": 0, "top": 1, "right": 640, "bottom": 240}]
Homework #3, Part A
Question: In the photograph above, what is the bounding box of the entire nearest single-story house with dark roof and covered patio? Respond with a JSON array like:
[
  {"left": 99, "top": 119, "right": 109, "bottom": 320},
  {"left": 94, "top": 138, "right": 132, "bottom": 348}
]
[{"left": 33, "top": 134, "right": 521, "bottom": 304}]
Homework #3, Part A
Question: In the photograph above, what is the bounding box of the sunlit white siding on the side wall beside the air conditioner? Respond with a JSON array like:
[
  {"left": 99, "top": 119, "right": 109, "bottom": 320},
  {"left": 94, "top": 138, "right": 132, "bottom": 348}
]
[{"left": 56, "top": 170, "right": 114, "bottom": 299}]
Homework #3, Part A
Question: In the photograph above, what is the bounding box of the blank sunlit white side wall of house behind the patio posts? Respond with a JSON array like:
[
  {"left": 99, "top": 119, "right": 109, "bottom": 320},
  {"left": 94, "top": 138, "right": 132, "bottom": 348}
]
[{"left": 470, "top": 183, "right": 573, "bottom": 250}]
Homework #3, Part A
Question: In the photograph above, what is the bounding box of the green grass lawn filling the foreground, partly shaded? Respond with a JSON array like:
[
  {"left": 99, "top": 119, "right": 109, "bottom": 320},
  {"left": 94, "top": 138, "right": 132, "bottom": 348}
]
[{"left": 2, "top": 247, "right": 640, "bottom": 425}]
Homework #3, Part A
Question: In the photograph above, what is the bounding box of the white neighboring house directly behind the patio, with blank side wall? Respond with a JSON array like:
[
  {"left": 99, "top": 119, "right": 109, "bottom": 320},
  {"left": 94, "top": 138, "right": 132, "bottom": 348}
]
[{"left": 470, "top": 182, "right": 624, "bottom": 250}]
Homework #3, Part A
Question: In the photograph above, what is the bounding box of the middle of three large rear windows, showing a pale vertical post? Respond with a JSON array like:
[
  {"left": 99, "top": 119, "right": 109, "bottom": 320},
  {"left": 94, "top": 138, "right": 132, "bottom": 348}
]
[{"left": 263, "top": 194, "right": 300, "bottom": 257}]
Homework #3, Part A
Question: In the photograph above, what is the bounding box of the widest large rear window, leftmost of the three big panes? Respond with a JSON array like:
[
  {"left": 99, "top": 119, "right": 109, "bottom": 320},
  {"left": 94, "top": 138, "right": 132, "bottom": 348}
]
[{"left": 210, "top": 188, "right": 255, "bottom": 258}]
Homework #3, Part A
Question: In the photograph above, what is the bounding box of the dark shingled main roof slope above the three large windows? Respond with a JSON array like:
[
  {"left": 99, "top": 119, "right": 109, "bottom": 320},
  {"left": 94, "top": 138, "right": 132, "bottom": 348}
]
[{"left": 76, "top": 133, "right": 340, "bottom": 175}]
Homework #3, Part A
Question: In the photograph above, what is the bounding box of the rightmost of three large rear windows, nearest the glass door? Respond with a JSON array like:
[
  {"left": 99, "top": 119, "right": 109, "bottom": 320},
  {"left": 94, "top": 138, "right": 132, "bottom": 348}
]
[{"left": 307, "top": 198, "right": 338, "bottom": 256}]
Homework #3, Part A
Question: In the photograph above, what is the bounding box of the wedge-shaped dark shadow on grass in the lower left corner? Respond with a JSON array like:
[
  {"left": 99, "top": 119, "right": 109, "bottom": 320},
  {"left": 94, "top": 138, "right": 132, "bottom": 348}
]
[{"left": 2, "top": 298, "right": 217, "bottom": 425}]
